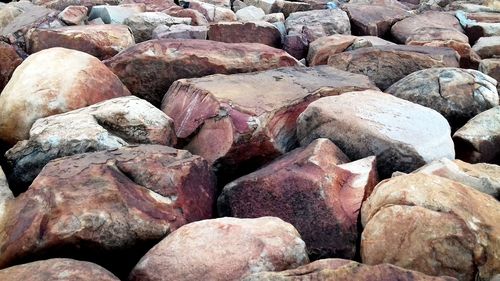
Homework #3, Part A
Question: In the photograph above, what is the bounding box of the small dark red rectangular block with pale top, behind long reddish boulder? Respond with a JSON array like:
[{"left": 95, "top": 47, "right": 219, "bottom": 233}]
[{"left": 208, "top": 21, "right": 281, "bottom": 48}]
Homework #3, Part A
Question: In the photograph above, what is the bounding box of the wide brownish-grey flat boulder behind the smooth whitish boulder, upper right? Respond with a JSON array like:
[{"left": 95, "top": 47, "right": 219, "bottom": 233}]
[{"left": 328, "top": 45, "right": 459, "bottom": 90}]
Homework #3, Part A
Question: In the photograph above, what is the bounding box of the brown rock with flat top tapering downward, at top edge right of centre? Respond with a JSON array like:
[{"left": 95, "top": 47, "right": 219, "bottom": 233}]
[{"left": 342, "top": 4, "right": 410, "bottom": 37}]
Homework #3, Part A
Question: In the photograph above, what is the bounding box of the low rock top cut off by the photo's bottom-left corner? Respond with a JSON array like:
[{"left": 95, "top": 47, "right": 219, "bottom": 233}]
[{"left": 0, "top": 258, "right": 120, "bottom": 281}]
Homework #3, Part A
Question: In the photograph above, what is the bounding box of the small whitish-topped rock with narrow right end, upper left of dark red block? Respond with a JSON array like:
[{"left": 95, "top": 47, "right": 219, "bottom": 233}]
[{"left": 123, "top": 12, "right": 191, "bottom": 43}]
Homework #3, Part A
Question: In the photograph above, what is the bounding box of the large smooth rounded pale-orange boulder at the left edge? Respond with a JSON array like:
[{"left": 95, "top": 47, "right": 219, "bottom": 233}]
[{"left": 0, "top": 48, "right": 130, "bottom": 144}]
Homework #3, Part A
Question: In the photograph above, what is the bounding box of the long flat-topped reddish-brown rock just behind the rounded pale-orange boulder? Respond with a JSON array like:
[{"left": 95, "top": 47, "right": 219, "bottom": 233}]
[{"left": 27, "top": 24, "right": 135, "bottom": 60}]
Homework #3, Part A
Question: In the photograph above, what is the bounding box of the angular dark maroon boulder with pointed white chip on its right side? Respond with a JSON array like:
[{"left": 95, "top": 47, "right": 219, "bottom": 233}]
[{"left": 218, "top": 139, "right": 377, "bottom": 259}]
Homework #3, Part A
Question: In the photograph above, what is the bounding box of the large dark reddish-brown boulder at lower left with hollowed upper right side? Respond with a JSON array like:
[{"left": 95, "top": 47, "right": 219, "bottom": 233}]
[{"left": 0, "top": 145, "right": 215, "bottom": 275}]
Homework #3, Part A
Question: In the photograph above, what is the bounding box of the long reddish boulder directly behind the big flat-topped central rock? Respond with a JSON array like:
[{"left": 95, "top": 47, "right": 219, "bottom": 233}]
[{"left": 101, "top": 39, "right": 299, "bottom": 105}]
